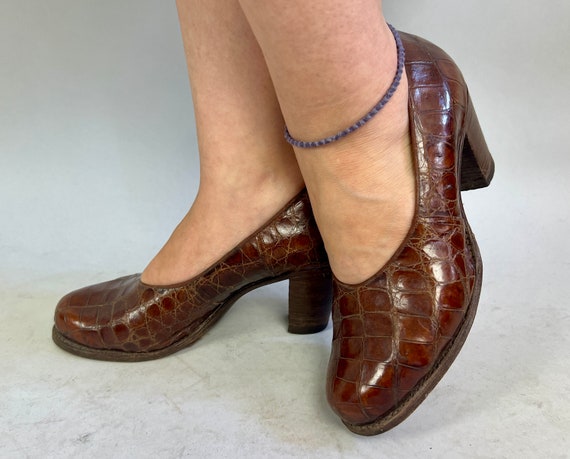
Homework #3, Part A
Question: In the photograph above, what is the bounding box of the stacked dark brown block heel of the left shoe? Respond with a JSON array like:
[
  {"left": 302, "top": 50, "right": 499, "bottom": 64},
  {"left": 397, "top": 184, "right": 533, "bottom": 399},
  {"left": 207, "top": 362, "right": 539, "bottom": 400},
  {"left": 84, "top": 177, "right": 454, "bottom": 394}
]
[{"left": 288, "top": 270, "right": 332, "bottom": 334}]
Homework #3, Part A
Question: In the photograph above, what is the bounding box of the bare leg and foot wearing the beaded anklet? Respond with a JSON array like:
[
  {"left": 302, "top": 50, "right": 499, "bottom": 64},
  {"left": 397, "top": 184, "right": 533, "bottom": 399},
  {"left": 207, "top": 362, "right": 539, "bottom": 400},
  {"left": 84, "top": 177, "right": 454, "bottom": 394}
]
[{"left": 235, "top": 0, "right": 415, "bottom": 283}]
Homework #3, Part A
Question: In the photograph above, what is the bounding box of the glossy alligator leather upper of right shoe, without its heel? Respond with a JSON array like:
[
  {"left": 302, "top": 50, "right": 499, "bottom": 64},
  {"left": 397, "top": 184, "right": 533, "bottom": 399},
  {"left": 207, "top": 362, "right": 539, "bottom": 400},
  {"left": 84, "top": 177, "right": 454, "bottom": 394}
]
[{"left": 327, "top": 33, "right": 481, "bottom": 433}]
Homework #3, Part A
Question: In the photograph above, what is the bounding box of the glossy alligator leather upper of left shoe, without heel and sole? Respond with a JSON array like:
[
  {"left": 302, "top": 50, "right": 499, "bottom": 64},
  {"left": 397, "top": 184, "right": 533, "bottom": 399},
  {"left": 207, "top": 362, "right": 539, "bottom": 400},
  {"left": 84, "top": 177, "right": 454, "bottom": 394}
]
[{"left": 55, "top": 191, "right": 328, "bottom": 358}]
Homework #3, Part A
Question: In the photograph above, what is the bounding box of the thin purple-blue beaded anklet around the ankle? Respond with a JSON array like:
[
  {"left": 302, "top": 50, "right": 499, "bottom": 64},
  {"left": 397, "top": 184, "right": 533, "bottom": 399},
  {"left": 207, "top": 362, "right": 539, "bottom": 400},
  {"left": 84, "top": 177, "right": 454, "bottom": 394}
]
[{"left": 285, "top": 24, "right": 405, "bottom": 148}]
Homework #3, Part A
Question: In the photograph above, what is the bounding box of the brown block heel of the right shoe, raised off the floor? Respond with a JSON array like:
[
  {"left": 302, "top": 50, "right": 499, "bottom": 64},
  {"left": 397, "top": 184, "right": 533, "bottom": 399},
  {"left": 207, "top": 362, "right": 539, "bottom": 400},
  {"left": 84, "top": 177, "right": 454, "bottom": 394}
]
[{"left": 461, "top": 99, "right": 495, "bottom": 191}]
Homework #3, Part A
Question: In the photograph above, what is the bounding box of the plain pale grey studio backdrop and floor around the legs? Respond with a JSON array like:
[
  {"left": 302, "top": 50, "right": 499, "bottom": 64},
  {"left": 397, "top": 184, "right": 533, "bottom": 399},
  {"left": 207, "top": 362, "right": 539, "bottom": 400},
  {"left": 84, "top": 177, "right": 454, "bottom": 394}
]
[{"left": 0, "top": 0, "right": 570, "bottom": 458}]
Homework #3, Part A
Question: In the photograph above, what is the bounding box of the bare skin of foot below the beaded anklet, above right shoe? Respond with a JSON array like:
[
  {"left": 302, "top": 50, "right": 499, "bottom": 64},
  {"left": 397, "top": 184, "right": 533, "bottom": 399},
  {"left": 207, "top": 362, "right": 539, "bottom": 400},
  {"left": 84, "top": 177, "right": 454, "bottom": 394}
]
[{"left": 142, "top": 160, "right": 303, "bottom": 285}]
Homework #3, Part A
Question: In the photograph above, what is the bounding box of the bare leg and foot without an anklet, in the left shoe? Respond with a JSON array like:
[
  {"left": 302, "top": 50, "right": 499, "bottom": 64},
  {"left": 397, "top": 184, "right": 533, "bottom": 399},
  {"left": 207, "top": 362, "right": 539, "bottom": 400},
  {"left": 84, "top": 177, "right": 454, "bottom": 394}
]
[{"left": 143, "top": 0, "right": 303, "bottom": 285}]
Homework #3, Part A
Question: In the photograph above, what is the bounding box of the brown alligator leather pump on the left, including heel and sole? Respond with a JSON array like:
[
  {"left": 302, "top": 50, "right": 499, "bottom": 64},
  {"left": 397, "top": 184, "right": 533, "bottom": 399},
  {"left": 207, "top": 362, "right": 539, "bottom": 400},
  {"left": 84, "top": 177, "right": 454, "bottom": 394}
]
[{"left": 52, "top": 191, "right": 332, "bottom": 362}]
